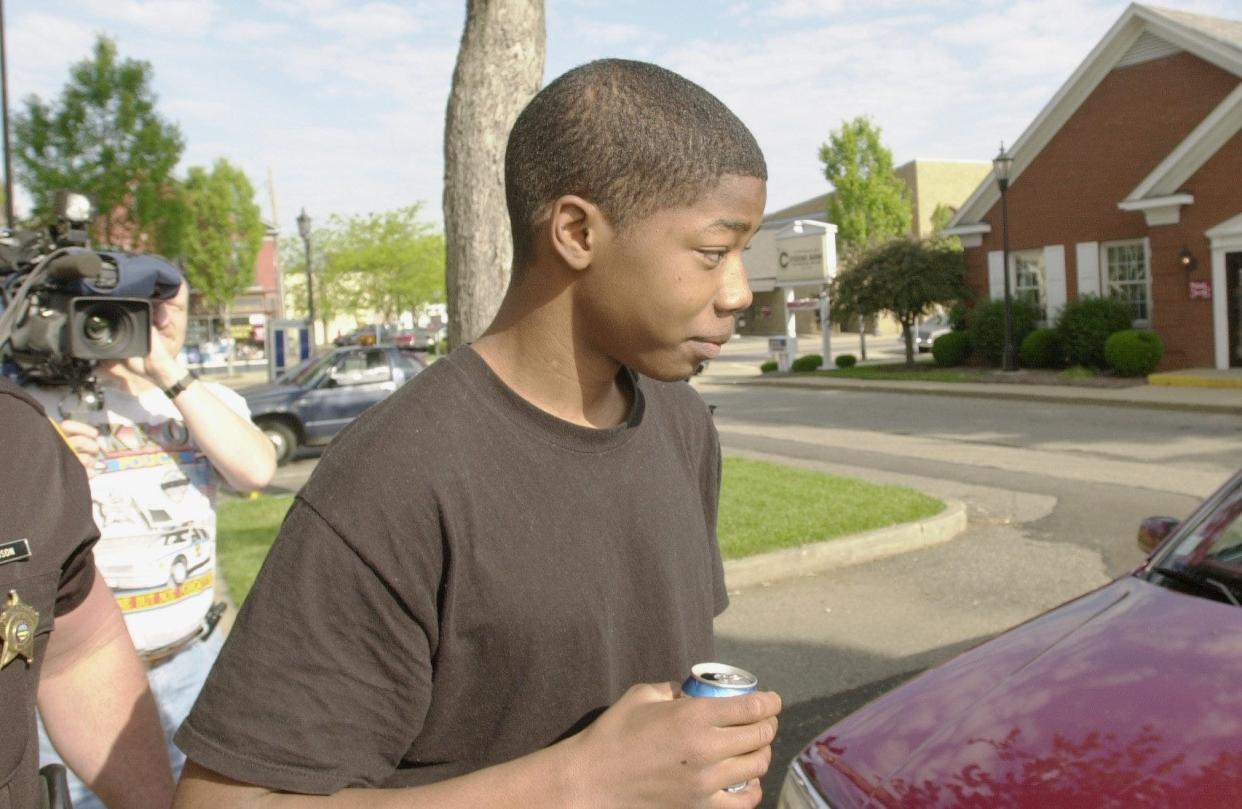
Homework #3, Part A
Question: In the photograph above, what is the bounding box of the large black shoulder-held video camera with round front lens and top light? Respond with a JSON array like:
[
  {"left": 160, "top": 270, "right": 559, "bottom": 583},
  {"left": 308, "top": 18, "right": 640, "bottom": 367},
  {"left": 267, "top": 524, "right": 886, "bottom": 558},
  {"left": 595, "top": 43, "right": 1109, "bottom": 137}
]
[{"left": 0, "top": 191, "right": 181, "bottom": 406}]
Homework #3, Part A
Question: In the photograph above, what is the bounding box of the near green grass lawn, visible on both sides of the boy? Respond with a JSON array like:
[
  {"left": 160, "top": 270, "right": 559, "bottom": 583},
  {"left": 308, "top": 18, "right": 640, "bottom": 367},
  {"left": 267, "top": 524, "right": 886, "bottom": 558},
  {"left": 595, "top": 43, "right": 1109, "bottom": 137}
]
[{"left": 216, "top": 457, "right": 944, "bottom": 604}]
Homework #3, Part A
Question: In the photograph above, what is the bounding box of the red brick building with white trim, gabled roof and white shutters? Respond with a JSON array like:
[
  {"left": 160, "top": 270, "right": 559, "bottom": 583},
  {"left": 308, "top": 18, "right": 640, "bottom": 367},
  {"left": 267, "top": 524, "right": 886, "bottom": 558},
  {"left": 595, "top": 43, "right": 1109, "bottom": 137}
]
[{"left": 946, "top": 4, "right": 1242, "bottom": 369}]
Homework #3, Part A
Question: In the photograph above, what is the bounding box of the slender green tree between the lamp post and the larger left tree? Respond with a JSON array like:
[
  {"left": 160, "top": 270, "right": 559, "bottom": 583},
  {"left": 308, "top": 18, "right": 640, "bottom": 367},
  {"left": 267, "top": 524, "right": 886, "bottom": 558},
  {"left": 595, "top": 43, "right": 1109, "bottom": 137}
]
[{"left": 183, "top": 159, "right": 267, "bottom": 363}]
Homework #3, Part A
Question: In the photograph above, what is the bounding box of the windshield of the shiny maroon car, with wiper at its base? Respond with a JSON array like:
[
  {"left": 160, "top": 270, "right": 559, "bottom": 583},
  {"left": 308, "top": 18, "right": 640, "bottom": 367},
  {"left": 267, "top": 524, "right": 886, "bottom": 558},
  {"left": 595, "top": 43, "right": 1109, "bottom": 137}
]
[{"left": 1153, "top": 483, "right": 1242, "bottom": 600}]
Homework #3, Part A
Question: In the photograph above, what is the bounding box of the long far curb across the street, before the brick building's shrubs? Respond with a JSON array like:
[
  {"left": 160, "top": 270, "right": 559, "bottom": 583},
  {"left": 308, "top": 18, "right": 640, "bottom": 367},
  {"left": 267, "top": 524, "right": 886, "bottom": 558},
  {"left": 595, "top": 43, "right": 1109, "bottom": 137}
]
[{"left": 703, "top": 377, "right": 1242, "bottom": 415}]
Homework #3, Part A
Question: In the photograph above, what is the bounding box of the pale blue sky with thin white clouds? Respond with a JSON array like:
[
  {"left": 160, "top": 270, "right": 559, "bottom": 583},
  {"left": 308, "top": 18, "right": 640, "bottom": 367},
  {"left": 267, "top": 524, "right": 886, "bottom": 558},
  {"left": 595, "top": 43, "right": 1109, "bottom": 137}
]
[{"left": 5, "top": 0, "right": 1242, "bottom": 232}]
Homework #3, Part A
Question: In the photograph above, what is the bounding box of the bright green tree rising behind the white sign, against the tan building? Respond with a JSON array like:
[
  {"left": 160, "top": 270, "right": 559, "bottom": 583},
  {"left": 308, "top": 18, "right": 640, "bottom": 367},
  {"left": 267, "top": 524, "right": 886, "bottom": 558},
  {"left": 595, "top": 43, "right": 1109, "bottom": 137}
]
[{"left": 820, "top": 117, "right": 914, "bottom": 256}]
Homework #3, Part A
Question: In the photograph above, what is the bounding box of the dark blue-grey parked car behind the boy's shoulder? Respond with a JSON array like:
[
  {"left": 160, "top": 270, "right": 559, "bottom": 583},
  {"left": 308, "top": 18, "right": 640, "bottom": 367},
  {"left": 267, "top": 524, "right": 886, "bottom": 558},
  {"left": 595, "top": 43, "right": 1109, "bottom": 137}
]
[{"left": 240, "top": 345, "right": 426, "bottom": 464}]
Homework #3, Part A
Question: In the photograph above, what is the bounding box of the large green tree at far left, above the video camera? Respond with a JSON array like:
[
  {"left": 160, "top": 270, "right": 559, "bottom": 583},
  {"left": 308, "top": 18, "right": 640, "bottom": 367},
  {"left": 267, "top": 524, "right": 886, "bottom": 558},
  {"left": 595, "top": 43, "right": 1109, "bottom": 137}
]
[{"left": 14, "top": 36, "right": 186, "bottom": 256}]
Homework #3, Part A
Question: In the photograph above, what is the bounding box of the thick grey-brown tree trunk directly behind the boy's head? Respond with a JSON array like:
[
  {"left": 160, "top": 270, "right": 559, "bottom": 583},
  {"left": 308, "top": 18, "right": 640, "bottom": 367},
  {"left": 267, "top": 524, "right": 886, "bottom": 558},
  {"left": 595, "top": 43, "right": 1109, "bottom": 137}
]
[{"left": 443, "top": 0, "right": 544, "bottom": 348}]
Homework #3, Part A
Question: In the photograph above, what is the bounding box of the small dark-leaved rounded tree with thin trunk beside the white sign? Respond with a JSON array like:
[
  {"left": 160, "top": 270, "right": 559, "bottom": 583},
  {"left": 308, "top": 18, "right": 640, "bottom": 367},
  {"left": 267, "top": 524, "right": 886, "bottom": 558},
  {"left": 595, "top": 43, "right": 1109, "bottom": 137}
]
[{"left": 832, "top": 239, "right": 970, "bottom": 368}]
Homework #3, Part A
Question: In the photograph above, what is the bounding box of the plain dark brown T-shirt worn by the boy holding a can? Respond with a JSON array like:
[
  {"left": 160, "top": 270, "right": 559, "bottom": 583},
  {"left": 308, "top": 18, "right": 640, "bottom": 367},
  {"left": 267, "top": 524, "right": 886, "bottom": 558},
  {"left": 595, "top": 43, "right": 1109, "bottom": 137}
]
[{"left": 176, "top": 348, "right": 727, "bottom": 794}]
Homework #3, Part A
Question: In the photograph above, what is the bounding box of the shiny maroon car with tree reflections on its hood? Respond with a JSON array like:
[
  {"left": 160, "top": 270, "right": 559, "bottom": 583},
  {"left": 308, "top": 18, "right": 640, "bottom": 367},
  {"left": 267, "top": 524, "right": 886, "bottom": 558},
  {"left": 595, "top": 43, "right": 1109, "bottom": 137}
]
[{"left": 779, "top": 473, "right": 1242, "bottom": 809}]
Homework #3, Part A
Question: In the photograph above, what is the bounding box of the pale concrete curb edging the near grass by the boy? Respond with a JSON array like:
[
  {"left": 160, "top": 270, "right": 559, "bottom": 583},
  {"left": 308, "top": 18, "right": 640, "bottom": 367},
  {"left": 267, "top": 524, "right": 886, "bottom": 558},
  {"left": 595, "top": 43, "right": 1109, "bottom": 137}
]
[{"left": 724, "top": 500, "right": 966, "bottom": 590}]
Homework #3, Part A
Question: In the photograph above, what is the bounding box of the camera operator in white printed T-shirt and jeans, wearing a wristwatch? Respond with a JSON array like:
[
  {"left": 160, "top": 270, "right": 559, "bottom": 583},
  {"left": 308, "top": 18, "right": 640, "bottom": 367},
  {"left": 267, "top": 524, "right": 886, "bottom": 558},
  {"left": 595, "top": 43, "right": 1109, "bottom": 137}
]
[{"left": 27, "top": 282, "right": 276, "bottom": 807}]
